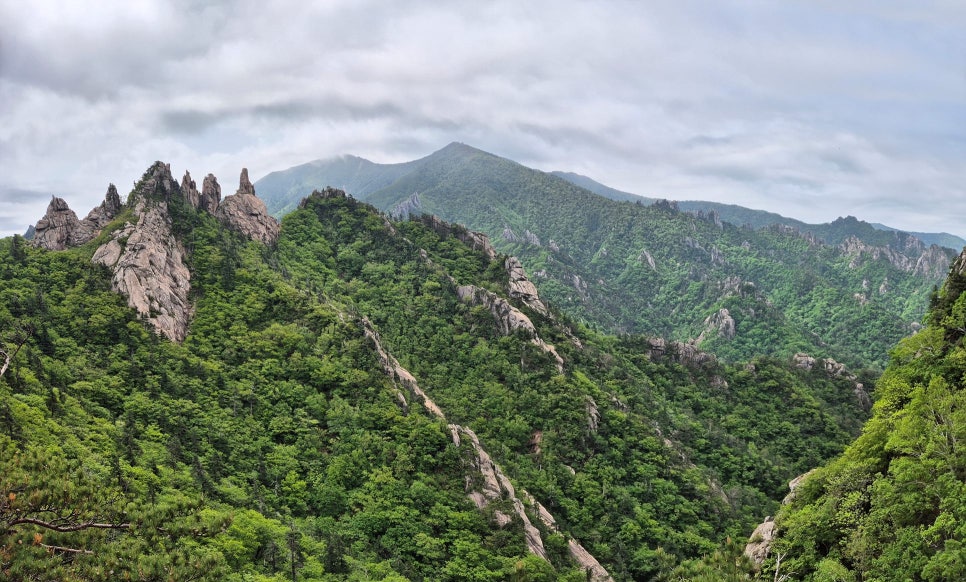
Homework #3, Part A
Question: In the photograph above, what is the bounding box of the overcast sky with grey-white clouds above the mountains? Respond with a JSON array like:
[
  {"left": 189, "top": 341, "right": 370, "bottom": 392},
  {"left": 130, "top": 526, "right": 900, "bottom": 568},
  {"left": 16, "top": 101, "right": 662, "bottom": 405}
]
[{"left": 0, "top": 0, "right": 966, "bottom": 236}]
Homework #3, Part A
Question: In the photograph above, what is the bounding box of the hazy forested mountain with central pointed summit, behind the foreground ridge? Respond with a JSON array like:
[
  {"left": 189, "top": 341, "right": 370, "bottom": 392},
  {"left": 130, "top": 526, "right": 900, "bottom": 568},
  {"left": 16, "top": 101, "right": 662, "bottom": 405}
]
[{"left": 255, "top": 144, "right": 954, "bottom": 369}]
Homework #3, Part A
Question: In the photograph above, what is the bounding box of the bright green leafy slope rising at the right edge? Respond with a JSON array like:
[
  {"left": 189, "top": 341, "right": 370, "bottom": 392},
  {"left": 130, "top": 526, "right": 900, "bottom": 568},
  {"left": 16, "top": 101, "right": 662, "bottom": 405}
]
[{"left": 769, "top": 253, "right": 966, "bottom": 581}]
